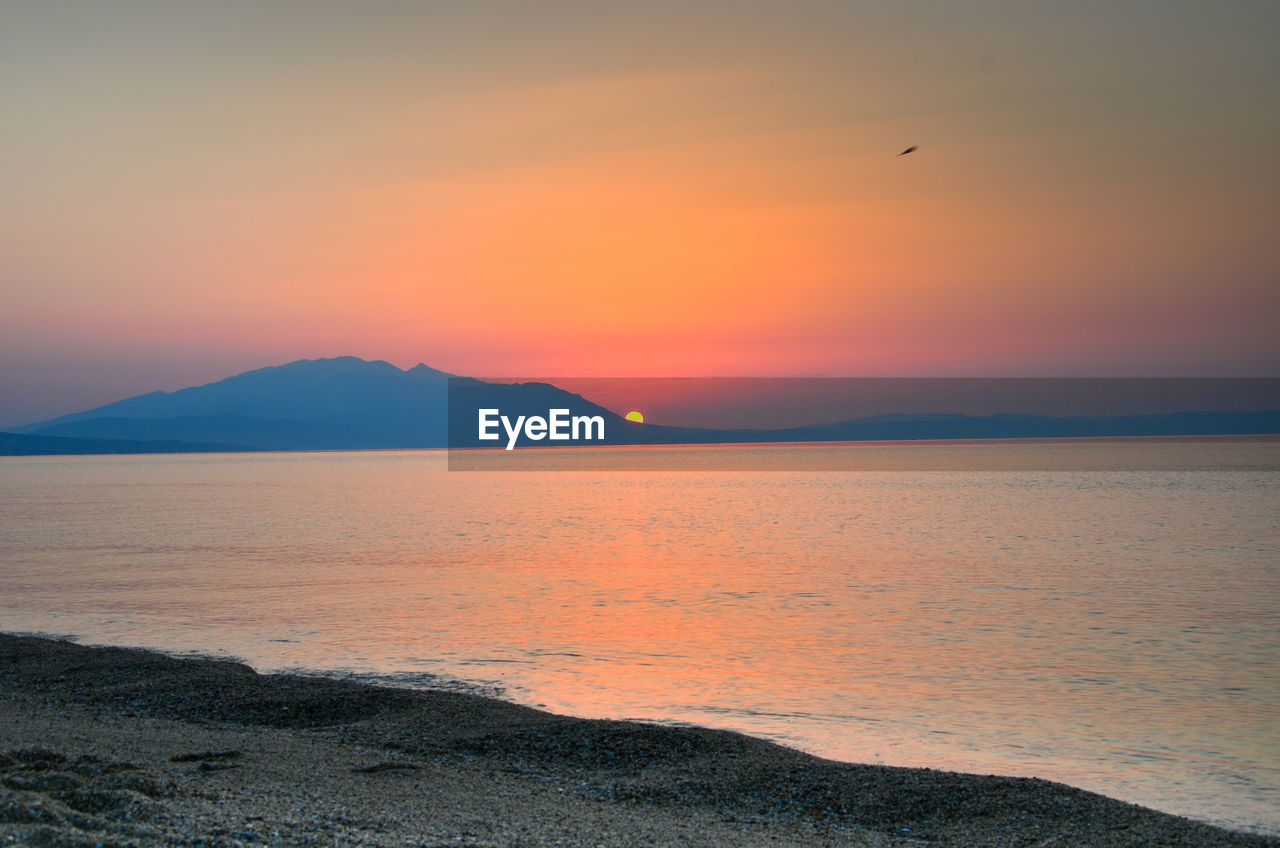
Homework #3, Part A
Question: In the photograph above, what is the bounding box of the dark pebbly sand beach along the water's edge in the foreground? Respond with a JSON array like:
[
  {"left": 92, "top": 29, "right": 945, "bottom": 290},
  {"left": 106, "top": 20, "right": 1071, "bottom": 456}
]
[{"left": 0, "top": 635, "right": 1280, "bottom": 848}]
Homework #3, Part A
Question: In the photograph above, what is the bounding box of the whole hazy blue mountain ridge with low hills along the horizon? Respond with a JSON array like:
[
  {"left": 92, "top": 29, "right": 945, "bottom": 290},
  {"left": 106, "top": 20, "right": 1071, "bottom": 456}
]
[{"left": 10, "top": 356, "right": 1280, "bottom": 453}]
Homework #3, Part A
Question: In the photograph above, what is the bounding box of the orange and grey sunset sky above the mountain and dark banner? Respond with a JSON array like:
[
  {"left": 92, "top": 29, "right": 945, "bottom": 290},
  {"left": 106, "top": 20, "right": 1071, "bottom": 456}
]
[{"left": 0, "top": 0, "right": 1280, "bottom": 425}]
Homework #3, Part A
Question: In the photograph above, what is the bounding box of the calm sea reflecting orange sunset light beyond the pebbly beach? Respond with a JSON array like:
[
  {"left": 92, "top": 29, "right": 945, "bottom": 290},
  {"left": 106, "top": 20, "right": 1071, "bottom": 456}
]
[{"left": 0, "top": 442, "right": 1280, "bottom": 833}]
